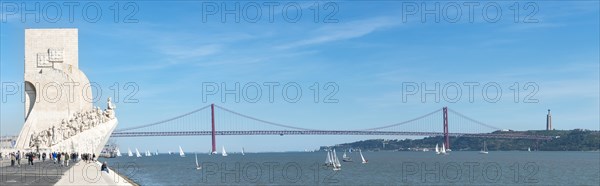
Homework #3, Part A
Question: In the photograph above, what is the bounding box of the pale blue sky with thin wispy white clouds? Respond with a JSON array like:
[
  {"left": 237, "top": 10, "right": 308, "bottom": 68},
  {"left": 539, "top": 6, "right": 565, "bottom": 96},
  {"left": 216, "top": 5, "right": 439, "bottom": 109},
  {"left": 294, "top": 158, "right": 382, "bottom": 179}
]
[{"left": 0, "top": 1, "right": 600, "bottom": 152}]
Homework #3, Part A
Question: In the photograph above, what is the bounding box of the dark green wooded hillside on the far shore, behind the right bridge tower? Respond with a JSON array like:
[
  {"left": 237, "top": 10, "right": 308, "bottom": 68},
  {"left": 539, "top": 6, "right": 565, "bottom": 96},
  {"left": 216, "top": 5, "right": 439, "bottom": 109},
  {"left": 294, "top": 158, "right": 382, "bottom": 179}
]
[{"left": 319, "top": 129, "right": 600, "bottom": 152}]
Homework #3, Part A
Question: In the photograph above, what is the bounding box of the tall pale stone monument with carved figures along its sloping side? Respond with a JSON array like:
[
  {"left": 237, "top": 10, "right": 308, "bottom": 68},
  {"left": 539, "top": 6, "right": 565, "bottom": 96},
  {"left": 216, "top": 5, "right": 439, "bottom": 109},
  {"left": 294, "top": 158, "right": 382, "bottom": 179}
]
[{"left": 15, "top": 29, "right": 118, "bottom": 154}]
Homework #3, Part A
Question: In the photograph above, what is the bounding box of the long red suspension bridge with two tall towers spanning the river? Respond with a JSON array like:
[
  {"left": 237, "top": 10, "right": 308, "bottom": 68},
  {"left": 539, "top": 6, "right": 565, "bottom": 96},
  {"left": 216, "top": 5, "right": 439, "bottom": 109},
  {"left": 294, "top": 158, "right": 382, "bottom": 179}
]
[{"left": 111, "top": 104, "right": 551, "bottom": 152}]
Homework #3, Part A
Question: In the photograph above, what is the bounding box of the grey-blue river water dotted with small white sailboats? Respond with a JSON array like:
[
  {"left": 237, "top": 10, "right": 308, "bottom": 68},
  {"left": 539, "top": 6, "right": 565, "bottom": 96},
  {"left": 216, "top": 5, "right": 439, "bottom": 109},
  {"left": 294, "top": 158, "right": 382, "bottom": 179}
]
[{"left": 101, "top": 151, "right": 600, "bottom": 185}]
